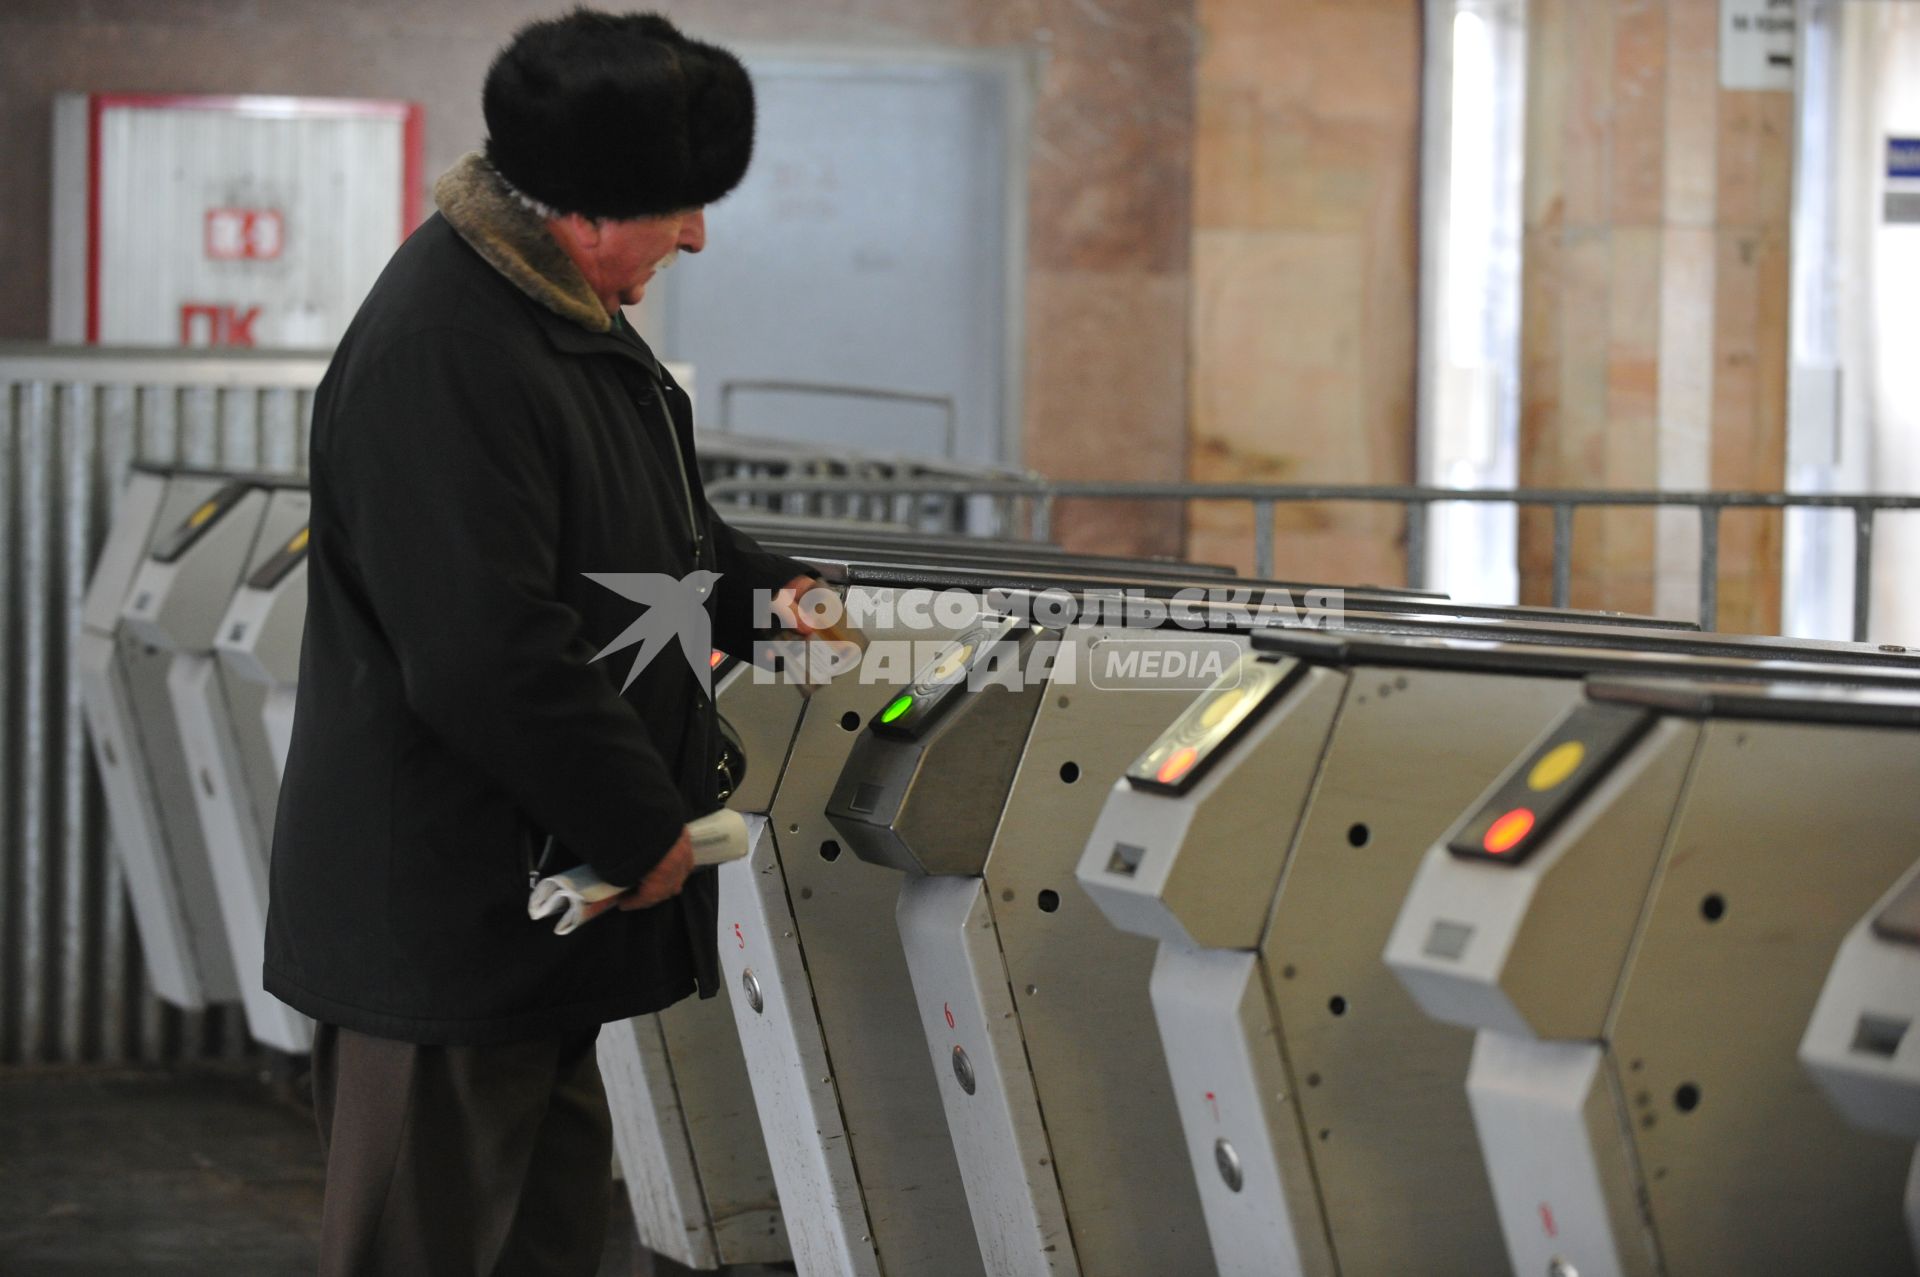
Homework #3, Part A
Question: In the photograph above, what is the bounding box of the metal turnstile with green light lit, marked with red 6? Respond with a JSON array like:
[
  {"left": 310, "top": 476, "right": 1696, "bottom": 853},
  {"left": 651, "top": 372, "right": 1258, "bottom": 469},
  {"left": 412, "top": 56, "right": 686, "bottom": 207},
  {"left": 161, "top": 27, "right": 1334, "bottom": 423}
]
[{"left": 829, "top": 622, "right": 1246, "bottom": 1273}]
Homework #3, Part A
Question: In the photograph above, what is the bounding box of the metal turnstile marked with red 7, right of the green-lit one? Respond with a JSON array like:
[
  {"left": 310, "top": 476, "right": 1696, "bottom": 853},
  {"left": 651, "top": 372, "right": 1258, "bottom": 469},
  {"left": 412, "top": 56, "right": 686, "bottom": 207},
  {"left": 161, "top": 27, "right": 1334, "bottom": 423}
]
[{"left": 1079, "top": 618, "right": 1920, "bottom": 1273}]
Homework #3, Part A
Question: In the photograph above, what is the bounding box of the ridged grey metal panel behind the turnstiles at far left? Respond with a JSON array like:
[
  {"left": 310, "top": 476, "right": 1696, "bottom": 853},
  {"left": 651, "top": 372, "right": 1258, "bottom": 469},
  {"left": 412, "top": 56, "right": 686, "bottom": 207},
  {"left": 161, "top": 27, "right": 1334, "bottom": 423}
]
[{"left": 0, "top": 348, "right": 326, "bottom": 1066}]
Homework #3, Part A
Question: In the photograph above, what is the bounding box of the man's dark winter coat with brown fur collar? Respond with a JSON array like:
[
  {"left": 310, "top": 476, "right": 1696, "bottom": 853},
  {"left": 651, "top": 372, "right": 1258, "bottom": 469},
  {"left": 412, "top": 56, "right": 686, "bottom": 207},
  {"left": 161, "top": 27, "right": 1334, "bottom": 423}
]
[{"left": 265, "top": 157, "right": 803, "bottom": 1043}]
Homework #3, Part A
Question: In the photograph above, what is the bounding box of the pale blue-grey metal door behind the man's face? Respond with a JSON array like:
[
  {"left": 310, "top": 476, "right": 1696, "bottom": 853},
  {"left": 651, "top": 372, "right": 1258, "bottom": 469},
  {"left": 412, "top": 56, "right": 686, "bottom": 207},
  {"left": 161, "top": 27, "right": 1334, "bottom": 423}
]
[{"left": 647, "top": 56, "right": 1025, "bottom": 463}]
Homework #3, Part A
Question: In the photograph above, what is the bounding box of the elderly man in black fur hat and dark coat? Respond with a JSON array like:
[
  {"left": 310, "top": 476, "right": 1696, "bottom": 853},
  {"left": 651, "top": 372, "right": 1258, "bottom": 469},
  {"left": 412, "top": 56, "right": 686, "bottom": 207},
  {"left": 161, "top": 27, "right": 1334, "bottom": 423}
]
[{"left": 265, "top": 10, "right": 808, "bottom": 1275}]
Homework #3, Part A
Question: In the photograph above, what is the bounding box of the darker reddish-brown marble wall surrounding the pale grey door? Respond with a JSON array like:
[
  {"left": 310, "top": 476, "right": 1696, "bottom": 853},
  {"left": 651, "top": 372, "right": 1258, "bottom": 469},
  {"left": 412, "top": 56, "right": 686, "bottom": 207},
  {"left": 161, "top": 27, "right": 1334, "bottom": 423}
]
[{"left": 0, "top": 0, "right": 1194, "bottom": 553}]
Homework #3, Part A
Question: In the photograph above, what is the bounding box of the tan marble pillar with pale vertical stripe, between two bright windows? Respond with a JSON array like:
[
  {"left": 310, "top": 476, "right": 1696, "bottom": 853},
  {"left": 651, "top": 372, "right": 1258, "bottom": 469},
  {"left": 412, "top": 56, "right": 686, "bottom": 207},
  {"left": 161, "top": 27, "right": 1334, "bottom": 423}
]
[{"left": 1521, "top": 0, "right": 1793, "bottom": 630}]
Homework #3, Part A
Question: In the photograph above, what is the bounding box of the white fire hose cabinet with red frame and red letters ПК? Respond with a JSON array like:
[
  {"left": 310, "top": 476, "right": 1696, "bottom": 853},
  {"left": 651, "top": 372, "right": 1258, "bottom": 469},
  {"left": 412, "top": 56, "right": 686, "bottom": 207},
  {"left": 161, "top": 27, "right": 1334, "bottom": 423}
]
[{"left": 48, "top": 92, "right": 422, "bottom": 349}]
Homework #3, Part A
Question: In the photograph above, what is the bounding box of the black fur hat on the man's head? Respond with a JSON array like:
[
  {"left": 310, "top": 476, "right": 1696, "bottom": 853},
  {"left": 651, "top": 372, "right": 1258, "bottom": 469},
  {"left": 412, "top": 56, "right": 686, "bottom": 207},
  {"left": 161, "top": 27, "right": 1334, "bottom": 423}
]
[{"left": 480, "top": 8, "right": 753, "bottom": 219}]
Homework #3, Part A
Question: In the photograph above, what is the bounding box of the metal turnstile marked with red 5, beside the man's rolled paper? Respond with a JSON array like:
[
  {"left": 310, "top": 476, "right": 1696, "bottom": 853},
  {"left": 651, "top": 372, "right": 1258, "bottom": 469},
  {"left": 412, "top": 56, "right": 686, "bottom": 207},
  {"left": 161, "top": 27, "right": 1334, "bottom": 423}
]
[{"left": 718, "top": 583, "right": 983, "bottom": 1277}]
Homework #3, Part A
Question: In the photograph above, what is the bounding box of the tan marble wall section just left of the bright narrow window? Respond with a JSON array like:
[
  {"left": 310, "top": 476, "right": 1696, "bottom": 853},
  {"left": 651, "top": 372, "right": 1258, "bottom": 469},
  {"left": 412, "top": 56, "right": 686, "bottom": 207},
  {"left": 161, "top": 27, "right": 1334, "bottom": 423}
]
[{"left": 1187, "top": 0, "right": 1421, "bottom": 584}]
